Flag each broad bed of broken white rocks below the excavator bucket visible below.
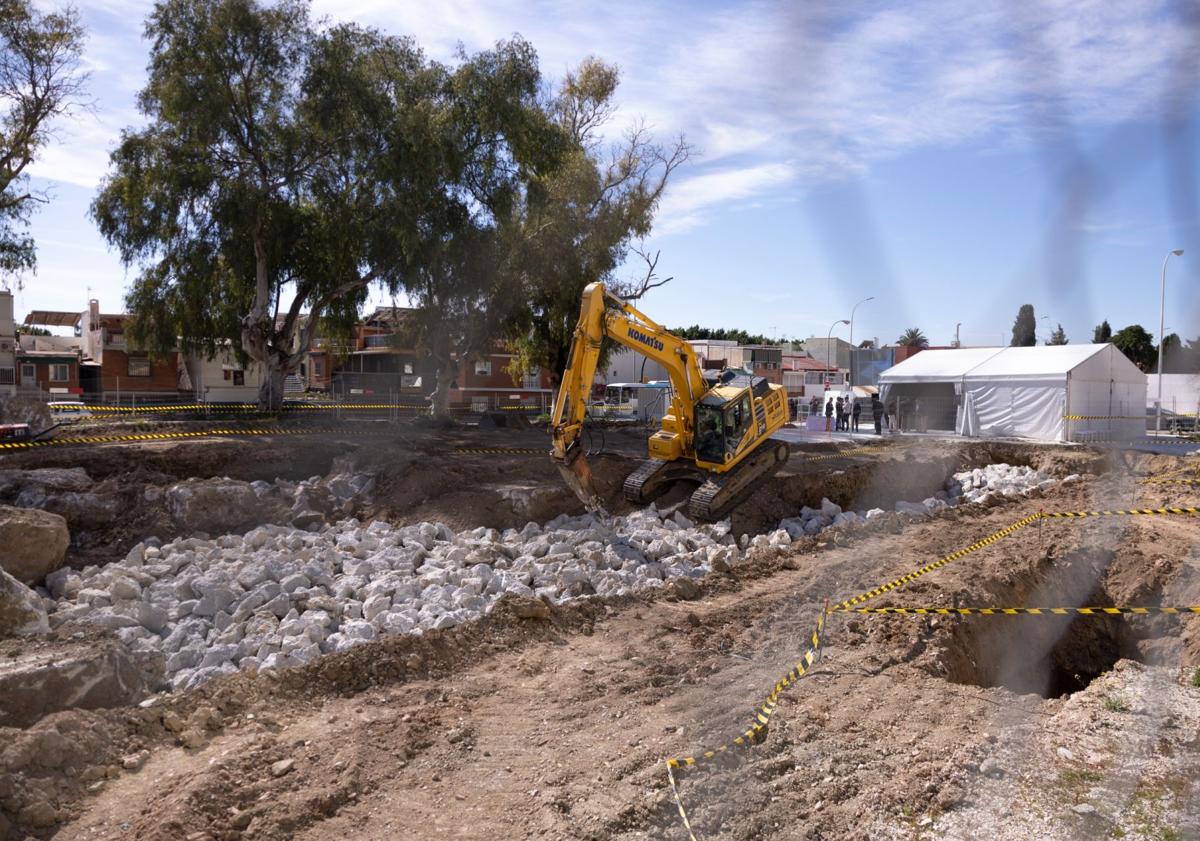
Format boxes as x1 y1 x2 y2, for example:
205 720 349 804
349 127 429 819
47 506 739 689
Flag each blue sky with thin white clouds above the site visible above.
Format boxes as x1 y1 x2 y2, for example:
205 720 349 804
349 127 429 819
17 0 1200 344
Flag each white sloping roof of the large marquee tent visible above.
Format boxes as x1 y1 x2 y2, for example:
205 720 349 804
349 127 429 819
880 344 1110 384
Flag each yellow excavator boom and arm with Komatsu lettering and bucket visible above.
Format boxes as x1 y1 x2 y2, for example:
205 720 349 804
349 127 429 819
551 283 708 511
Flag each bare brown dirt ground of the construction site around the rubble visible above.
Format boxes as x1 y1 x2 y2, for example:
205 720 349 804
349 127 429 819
0 425 1200 841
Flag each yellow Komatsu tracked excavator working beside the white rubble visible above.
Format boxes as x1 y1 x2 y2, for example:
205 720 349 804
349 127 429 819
551 283 788 522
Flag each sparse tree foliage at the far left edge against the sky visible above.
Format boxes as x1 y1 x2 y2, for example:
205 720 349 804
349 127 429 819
0 0 86 280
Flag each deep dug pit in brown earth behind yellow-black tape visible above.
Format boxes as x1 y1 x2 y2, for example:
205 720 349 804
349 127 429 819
937 548 1148 698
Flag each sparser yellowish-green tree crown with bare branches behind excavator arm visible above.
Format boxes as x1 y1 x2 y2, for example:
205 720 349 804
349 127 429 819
500 58 691 385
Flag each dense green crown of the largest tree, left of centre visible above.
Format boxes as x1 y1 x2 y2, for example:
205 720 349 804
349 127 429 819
92 0 547 406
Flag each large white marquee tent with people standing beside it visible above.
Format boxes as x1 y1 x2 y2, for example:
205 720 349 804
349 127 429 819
880 344 1146 440
